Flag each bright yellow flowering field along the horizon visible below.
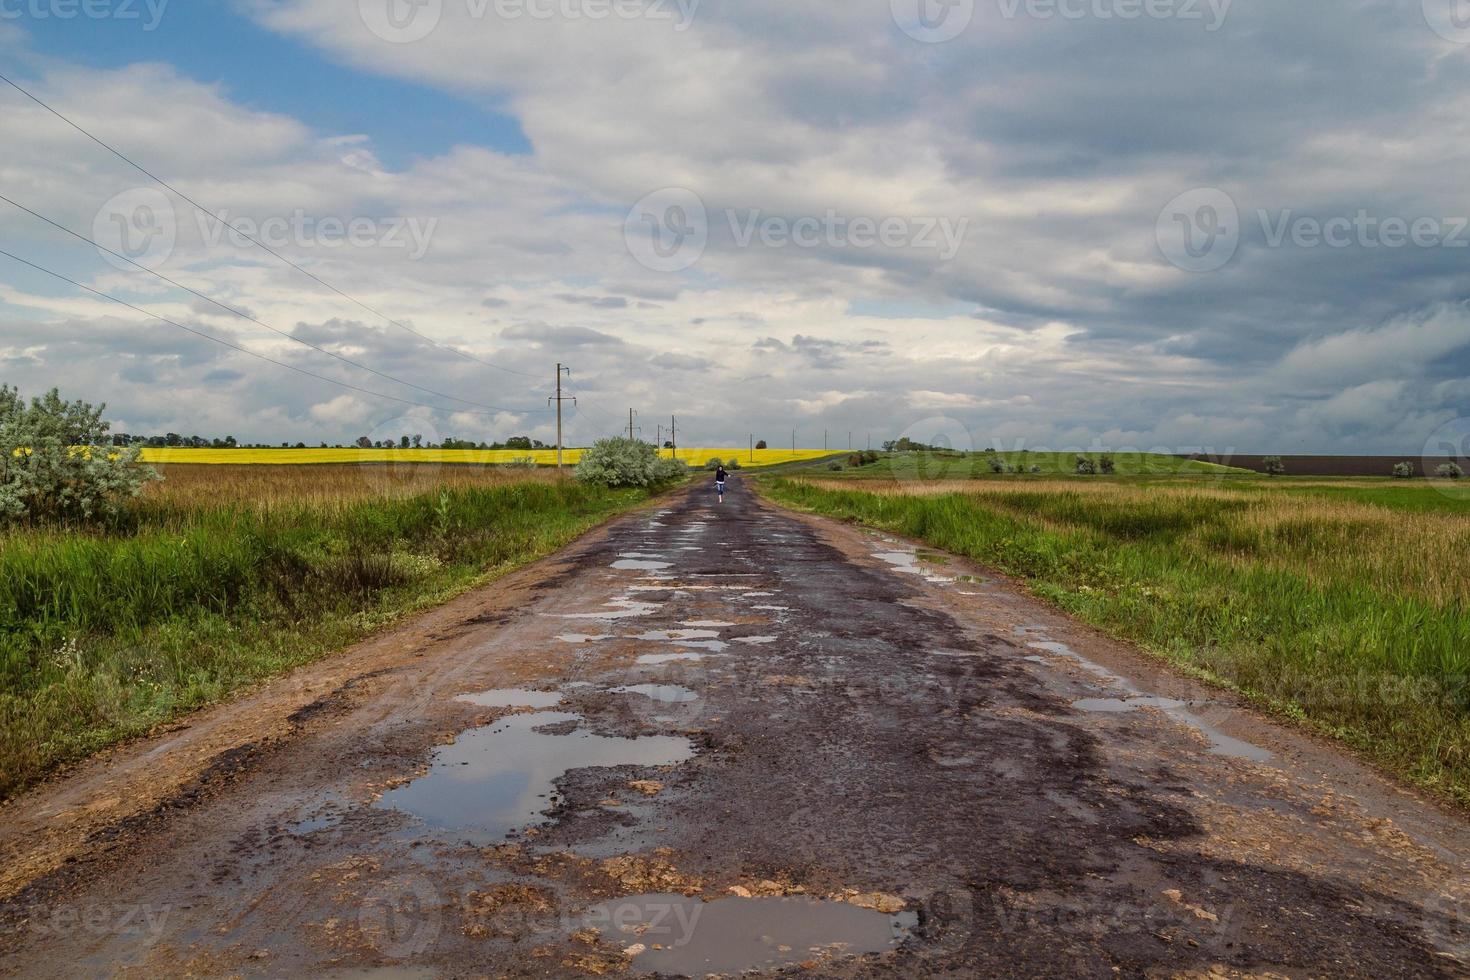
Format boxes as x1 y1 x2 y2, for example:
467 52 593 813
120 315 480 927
143 447 831 467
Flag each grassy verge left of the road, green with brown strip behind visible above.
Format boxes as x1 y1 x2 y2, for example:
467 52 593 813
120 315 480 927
0 466 647 796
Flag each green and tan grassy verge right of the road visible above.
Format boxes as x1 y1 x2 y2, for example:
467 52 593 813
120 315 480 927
766 467 1470 804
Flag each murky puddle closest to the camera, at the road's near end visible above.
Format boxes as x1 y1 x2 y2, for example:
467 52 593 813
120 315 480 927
587 895 917 977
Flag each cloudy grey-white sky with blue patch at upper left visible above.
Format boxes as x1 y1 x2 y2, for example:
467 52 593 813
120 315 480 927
0 0 1470 457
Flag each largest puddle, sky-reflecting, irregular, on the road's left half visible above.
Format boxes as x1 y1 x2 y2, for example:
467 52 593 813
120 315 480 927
373 711 694 843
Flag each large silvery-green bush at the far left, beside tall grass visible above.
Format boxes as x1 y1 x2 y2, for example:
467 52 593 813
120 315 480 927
0 385 159 523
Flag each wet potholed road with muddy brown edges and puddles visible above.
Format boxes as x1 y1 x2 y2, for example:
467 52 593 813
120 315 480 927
0 483 1470 977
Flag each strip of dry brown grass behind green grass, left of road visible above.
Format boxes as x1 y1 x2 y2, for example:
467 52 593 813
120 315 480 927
144 463 570 510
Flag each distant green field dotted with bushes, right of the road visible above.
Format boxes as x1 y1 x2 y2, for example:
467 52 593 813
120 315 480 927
832 453 1250 480
